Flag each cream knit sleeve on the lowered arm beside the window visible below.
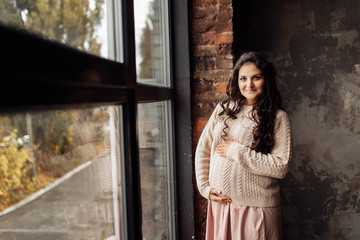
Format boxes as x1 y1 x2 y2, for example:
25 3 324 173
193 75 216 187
195 104 221 199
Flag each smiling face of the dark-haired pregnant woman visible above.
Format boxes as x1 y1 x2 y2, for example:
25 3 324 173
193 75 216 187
238 63 265 105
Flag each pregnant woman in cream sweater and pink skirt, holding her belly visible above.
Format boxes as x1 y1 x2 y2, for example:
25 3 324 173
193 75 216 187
195 52 291 240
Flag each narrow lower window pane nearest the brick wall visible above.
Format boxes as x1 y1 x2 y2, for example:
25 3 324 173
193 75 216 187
138 102 175 239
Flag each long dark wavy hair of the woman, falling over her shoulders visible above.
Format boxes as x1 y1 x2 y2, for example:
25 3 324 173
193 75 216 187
219 52 283 154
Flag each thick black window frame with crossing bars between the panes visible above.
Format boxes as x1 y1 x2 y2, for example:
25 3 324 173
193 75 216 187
0 0 195 239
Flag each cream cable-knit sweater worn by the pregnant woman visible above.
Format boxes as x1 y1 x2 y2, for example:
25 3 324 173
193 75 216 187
195 104 291 207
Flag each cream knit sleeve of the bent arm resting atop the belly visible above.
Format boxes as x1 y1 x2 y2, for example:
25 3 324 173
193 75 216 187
226 110 292 179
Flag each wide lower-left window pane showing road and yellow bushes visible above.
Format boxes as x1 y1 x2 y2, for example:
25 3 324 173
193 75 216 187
0 106 123 240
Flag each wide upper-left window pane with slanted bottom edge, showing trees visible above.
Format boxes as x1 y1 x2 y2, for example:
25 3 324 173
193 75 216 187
0 0 121 60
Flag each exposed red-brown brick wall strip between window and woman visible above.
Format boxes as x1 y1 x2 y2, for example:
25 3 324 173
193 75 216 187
190 0 234 239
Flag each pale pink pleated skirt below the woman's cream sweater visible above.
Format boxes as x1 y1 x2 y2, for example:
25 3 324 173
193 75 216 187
206 201 282 240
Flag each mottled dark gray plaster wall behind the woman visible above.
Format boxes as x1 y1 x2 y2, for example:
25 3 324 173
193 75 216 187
233 0 360 240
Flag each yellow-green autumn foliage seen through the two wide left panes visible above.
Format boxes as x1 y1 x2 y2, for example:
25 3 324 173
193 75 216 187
0 0 106 211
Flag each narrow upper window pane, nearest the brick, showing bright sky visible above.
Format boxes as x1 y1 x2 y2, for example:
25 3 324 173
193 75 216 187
134 0 171 87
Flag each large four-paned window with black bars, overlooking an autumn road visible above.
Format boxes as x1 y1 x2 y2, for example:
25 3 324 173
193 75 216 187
0 0 191 240
